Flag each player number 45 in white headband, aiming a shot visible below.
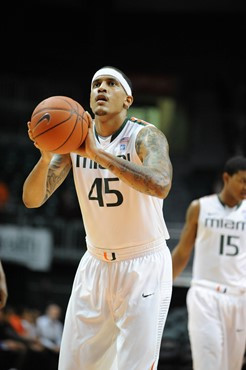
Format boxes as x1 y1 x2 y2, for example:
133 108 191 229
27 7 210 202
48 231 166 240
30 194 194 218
23 67 172 370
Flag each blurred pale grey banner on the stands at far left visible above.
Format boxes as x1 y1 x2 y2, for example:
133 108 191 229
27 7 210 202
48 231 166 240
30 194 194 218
0 225 53 271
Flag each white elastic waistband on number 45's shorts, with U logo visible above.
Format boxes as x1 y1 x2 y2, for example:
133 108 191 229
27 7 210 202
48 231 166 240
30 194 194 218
87 238 167 262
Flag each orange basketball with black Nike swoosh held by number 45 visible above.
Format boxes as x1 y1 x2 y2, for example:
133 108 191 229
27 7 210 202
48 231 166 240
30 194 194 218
30 96 88 154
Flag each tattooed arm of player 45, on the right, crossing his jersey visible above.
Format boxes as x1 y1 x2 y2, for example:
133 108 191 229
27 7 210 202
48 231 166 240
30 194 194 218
77 115 172 198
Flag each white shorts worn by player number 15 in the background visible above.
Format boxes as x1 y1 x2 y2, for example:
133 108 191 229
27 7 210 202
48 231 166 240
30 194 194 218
187 281 246 370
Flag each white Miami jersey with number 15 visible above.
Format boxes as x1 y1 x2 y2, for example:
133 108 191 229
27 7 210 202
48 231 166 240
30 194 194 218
193 194 246 288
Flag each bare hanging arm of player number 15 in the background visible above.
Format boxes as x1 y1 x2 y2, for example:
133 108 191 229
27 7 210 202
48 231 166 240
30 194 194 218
172 200 200 279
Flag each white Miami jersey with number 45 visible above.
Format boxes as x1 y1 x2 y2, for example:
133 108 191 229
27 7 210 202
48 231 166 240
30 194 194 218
71 118 169 250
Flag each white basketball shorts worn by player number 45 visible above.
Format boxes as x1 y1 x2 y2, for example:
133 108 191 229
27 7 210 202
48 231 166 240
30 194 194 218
58 239 172 370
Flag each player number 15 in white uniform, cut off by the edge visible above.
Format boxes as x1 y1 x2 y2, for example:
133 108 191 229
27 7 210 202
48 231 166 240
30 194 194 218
172 156 246 370
